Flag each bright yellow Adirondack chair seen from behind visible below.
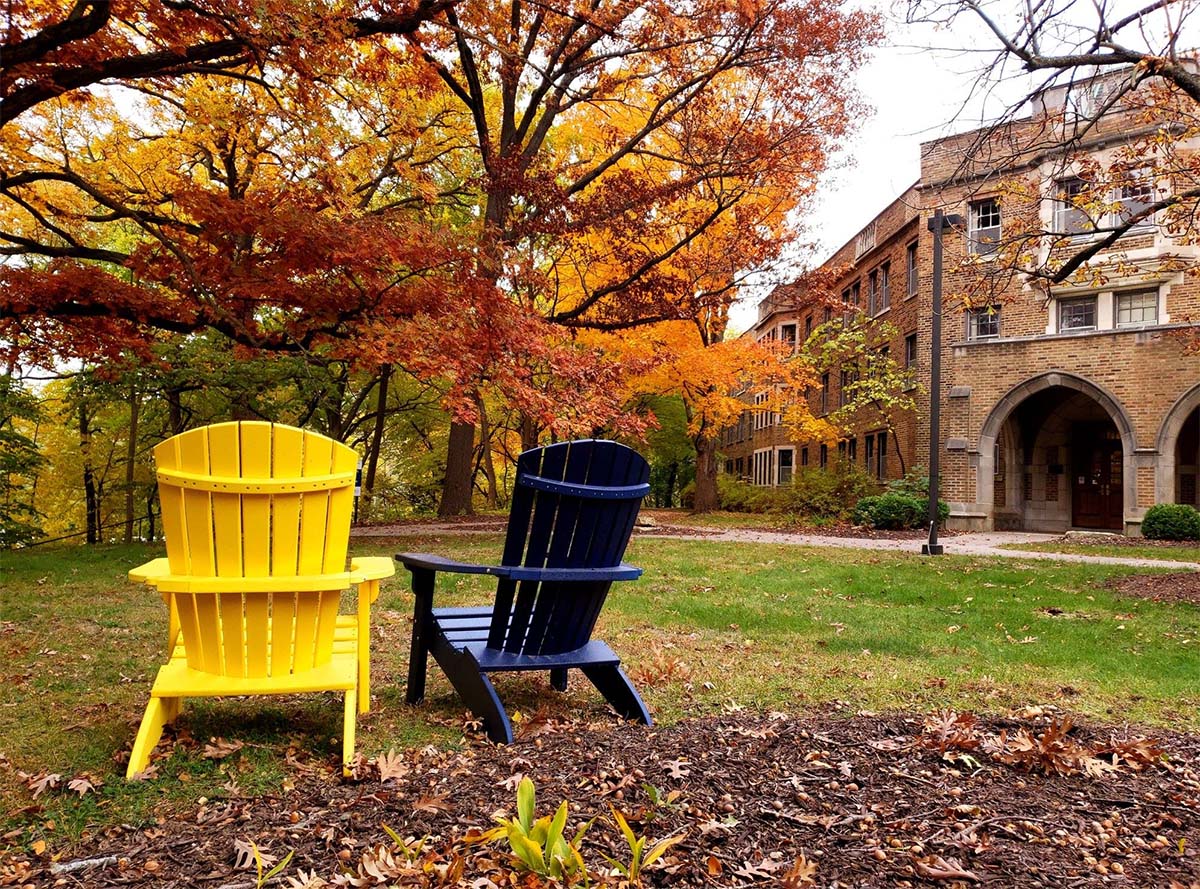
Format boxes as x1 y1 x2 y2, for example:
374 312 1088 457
126 422 395 779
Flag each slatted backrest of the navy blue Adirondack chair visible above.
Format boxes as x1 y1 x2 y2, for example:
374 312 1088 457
488 439 650 655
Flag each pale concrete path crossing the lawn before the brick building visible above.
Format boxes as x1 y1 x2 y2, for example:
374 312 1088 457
350 518 1200 571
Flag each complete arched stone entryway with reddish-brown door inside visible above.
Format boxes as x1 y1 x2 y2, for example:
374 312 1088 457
976 371 1138 531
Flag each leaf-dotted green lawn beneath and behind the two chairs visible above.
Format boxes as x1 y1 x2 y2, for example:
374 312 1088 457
0 535 1200 839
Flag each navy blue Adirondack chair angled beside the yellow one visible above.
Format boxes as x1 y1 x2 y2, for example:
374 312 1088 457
396 440 652 744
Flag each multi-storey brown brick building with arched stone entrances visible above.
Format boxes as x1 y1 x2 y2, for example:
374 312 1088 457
722 73 1200 534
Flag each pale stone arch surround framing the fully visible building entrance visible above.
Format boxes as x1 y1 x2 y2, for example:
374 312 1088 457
974 371 1132 522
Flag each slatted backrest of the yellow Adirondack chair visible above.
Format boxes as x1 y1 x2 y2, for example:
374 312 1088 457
155 421 358 678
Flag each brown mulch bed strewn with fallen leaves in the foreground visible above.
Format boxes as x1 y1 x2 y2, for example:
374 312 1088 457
9 708 1200 889
